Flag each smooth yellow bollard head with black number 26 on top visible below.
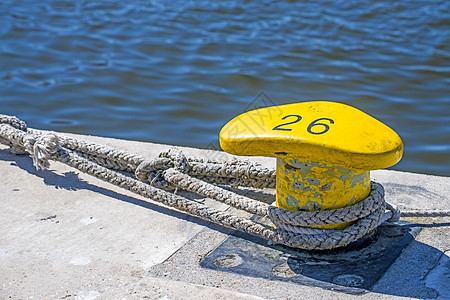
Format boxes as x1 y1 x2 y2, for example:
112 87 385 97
219 101 403 170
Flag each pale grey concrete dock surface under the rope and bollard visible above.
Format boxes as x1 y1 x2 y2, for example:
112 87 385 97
0 134 450 300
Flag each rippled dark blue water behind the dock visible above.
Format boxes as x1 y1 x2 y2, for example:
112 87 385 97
0 0 450 176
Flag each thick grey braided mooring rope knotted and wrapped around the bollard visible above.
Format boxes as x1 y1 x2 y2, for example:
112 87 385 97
0 115 450 250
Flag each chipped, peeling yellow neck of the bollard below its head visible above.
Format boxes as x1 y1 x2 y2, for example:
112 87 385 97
276 157 370 229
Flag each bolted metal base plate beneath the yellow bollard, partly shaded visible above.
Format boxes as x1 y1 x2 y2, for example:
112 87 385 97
200 222 420 294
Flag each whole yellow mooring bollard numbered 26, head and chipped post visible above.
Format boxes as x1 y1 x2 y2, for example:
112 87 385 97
220 101 403 229
